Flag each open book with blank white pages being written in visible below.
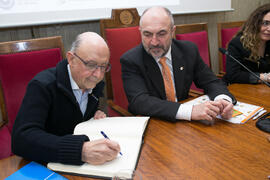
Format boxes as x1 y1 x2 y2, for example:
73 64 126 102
47 117 149 178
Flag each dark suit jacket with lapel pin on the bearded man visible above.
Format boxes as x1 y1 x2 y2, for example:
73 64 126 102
120 40 234 121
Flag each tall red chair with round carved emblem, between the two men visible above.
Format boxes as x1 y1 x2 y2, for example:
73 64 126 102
100 8 141 116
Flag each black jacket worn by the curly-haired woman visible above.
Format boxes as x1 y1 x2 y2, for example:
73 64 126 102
223 35 270 83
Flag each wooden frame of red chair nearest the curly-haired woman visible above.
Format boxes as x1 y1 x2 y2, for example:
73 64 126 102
217 21 245 77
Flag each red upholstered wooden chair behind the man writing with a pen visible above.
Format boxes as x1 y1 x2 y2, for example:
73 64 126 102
0 36 64 159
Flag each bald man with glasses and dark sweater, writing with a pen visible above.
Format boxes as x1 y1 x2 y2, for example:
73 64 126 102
12 32 120 164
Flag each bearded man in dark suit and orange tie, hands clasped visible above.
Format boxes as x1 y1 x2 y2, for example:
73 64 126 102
120 7 235 123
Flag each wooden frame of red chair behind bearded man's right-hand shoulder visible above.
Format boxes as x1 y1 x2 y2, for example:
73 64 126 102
175 22 212 97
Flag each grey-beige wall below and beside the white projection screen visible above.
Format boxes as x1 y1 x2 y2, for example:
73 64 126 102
0 0 270 119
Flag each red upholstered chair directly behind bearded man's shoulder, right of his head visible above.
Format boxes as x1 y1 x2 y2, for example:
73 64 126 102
175 23 211 96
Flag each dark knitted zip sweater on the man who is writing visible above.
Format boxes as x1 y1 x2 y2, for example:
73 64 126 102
12 60 104 164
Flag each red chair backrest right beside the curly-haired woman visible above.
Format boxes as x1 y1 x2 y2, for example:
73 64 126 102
217 21 245 74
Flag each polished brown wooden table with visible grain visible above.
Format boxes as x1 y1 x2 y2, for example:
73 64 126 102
0 84 270 180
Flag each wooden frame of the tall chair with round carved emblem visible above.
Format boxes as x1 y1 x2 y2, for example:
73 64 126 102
100 8 140 116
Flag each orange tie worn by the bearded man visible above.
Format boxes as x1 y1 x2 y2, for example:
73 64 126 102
159 57 175 102
